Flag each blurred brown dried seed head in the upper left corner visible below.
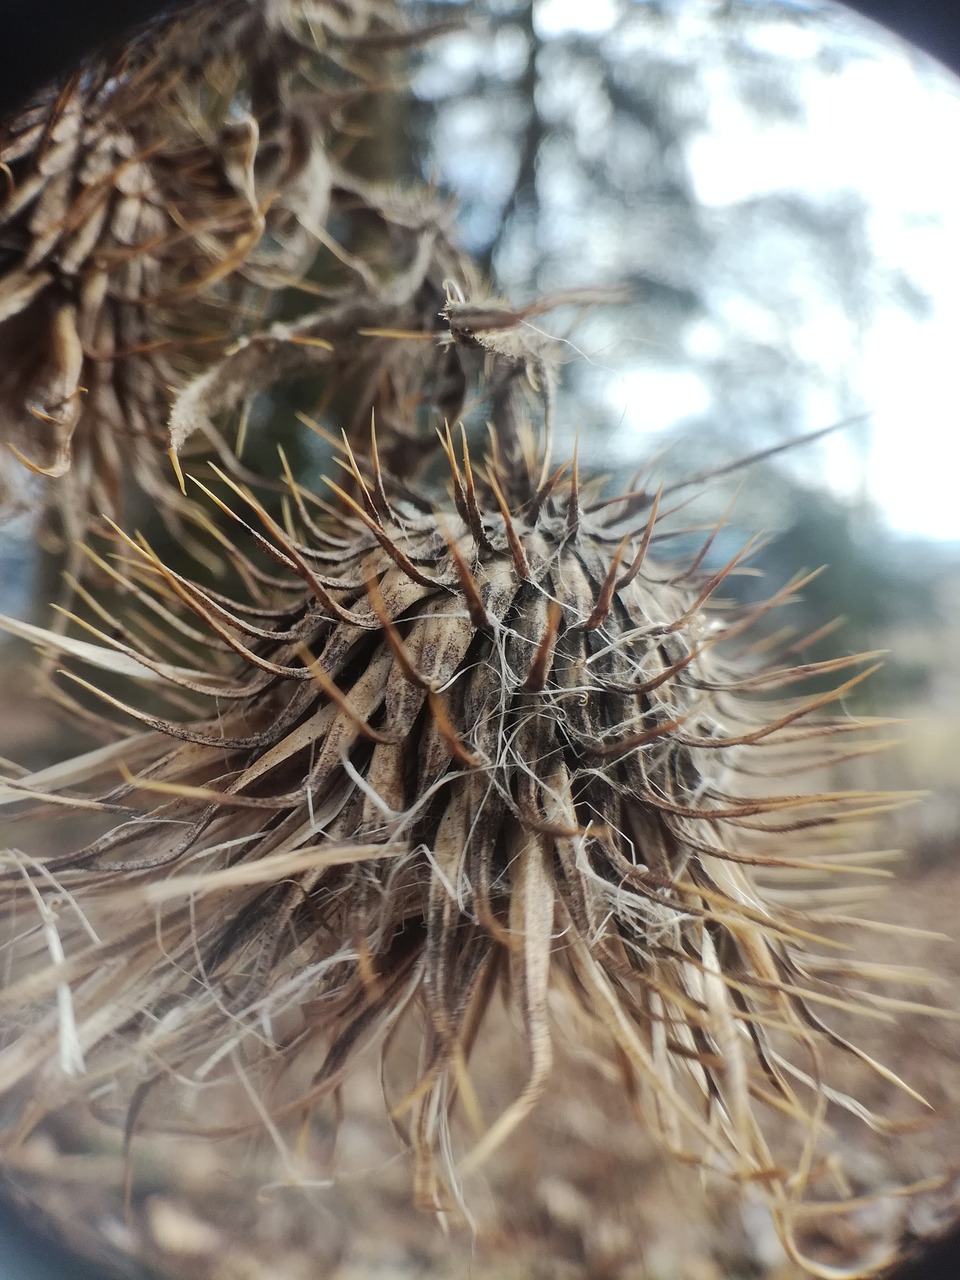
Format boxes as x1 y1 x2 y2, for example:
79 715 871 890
0 0 432 536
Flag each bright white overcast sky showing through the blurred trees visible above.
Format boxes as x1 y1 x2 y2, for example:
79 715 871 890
552 0 960 540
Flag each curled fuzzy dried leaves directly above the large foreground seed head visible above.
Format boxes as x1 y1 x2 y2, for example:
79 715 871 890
169 168 481 479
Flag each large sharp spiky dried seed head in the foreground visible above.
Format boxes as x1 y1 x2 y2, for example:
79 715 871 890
0 401 942 1269
